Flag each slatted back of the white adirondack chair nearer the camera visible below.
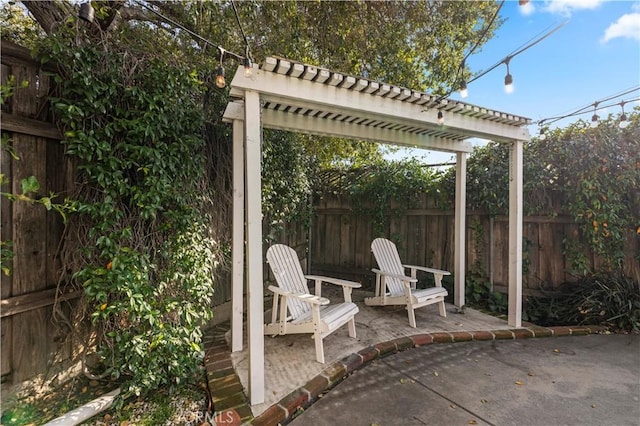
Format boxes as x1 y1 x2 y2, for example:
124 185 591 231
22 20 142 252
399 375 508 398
267 244 311 319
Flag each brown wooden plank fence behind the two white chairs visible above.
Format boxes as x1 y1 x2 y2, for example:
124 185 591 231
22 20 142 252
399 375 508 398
310 196 640 294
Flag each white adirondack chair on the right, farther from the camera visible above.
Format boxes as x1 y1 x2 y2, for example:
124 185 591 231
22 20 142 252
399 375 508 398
364 238 451 328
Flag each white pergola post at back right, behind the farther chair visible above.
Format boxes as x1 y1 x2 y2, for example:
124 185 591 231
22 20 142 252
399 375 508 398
453 152 467 307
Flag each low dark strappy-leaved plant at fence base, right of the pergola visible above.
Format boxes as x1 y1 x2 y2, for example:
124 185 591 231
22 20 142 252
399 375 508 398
524 273 640 332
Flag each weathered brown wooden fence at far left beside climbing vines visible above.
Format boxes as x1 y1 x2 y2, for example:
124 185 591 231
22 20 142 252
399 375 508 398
0 40 79 391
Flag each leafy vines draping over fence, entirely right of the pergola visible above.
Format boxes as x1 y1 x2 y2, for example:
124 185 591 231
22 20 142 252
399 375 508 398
525 113 640 274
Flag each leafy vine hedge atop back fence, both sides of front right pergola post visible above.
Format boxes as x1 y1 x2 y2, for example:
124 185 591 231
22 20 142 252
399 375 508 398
440 112 640 275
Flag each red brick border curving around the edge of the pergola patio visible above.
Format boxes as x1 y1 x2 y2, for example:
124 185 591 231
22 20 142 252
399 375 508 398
205 324 607 426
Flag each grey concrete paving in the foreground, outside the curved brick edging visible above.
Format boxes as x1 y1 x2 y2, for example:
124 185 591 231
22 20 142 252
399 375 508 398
291 335 640 426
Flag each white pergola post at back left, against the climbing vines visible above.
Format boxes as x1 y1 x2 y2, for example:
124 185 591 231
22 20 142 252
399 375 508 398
231 120 245 352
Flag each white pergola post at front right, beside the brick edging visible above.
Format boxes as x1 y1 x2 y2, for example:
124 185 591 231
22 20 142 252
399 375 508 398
508 140 523 327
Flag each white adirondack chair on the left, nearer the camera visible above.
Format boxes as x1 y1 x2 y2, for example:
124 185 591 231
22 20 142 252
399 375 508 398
264 244 361 364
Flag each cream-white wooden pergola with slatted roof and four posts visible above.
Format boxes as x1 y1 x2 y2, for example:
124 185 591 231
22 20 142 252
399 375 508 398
224 57 531 405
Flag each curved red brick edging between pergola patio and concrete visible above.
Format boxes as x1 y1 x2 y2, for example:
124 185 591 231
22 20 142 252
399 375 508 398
206 325 606 426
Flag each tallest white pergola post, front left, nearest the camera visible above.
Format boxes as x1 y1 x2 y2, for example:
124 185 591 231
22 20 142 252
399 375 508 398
244 91 264 405
